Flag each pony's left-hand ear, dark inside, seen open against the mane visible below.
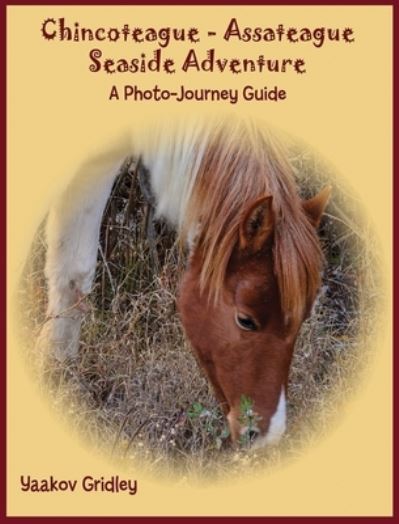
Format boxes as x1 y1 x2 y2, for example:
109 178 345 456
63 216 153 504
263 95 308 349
239 195 274 253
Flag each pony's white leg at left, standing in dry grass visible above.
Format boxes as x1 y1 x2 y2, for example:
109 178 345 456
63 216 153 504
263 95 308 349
37 149 126 360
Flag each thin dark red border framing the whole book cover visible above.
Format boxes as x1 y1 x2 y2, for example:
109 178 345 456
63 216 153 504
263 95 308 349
0 0 399 523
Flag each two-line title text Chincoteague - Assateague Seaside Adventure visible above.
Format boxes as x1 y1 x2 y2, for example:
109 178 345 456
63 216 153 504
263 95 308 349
40 17 355 101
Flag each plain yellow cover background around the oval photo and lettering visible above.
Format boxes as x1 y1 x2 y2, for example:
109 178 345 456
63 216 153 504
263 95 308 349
7 6 392 515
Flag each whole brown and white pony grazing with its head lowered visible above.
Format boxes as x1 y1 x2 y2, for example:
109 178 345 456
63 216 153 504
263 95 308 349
39 120 330 446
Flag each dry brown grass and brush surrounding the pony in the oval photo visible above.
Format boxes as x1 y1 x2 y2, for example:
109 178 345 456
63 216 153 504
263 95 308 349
20 144 380 484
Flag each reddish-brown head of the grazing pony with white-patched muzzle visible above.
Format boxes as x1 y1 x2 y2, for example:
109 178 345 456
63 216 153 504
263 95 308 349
179 188 330 445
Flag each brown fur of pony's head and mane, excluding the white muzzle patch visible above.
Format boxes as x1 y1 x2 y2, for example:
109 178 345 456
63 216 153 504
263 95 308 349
179 122 329 440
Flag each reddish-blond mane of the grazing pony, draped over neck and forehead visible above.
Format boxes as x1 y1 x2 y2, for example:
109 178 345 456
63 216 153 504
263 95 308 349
145 120 322 321
